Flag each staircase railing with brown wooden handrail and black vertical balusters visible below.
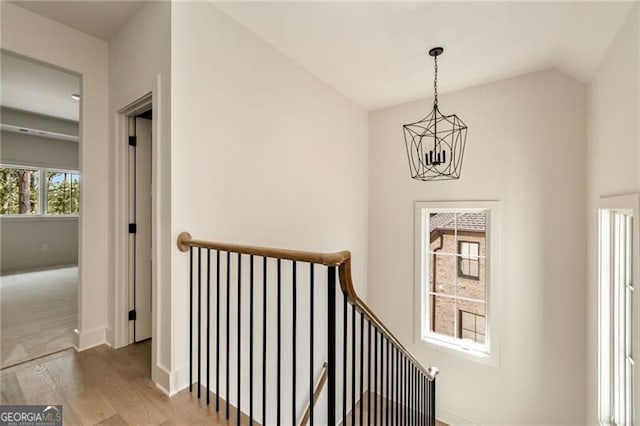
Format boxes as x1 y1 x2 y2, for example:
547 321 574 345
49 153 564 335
178 232 438 426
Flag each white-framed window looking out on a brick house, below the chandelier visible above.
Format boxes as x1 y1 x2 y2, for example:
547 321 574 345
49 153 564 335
416 201 498 365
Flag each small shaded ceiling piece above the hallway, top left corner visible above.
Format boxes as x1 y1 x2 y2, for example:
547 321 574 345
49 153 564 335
11 0 148 41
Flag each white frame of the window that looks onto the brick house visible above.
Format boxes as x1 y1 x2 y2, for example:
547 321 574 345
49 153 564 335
414 201 500 367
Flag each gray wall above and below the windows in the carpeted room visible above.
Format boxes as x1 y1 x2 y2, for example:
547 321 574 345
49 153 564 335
0 108 79 274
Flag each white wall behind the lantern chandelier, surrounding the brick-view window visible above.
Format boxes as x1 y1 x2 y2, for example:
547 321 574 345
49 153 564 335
368 71 586 425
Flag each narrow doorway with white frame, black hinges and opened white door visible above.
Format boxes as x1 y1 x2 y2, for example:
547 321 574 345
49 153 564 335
113 93 158 382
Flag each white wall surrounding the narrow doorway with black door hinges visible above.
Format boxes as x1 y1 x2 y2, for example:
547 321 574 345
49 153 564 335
107 2 175 390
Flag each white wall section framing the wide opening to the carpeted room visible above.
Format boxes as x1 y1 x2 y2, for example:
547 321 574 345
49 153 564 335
0 1 110 349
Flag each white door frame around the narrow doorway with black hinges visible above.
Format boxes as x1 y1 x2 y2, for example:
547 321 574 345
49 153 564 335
113 92 160 376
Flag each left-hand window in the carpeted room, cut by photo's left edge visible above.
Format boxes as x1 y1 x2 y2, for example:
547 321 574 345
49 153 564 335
0 166 40 215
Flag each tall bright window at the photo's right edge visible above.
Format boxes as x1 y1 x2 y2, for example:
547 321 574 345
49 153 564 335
598 196 640 425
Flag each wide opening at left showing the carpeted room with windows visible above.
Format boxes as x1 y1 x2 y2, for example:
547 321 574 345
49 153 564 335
0 51 82 368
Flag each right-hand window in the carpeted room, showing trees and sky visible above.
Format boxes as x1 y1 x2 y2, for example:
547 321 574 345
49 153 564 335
47 170 80 215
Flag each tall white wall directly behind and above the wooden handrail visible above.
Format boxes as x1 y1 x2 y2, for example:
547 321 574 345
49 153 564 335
171 2 368 413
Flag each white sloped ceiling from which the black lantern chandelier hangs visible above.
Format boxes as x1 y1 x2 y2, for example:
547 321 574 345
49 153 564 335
216 1 634 110
